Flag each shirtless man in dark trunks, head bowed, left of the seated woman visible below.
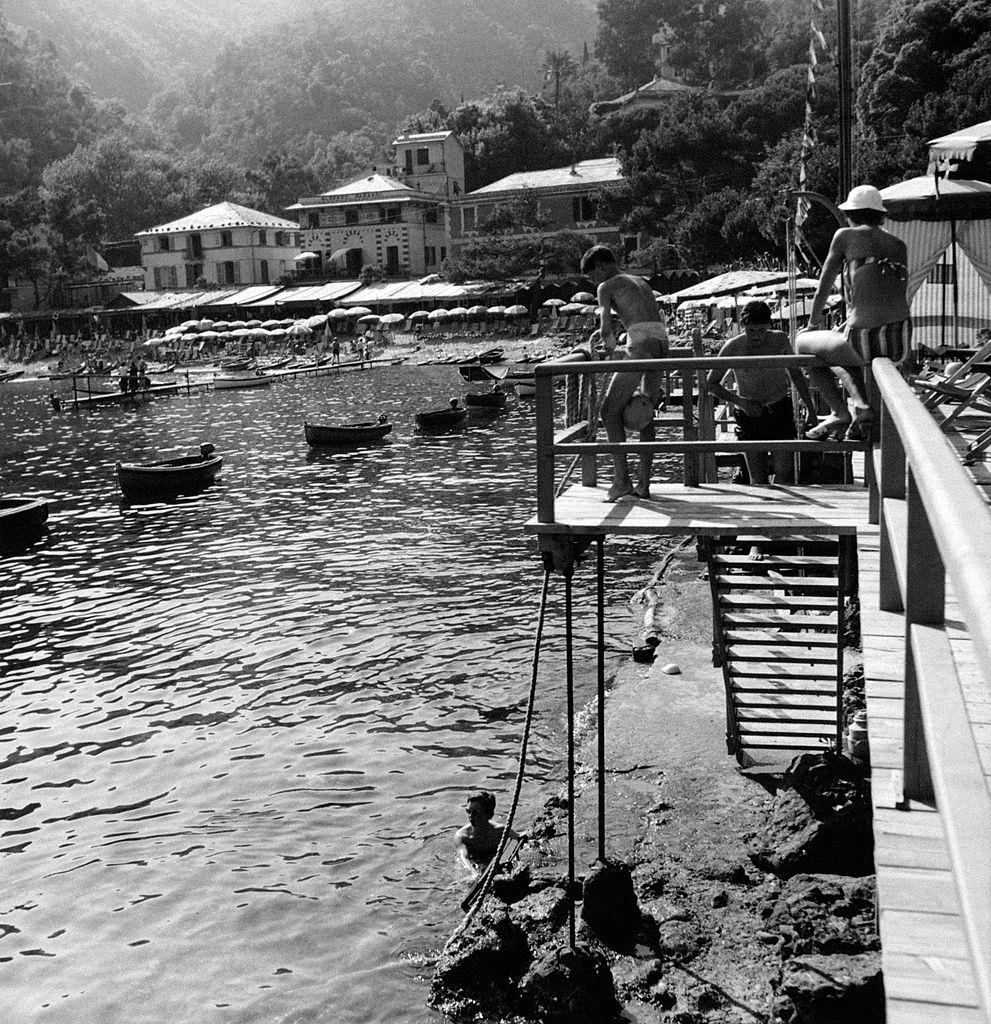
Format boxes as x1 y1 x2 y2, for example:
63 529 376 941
707 301 818 483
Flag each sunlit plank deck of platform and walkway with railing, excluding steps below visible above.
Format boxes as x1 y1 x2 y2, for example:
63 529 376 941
524 358 991 1024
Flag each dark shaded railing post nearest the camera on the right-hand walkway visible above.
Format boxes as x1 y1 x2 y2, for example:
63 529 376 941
902 468 946 801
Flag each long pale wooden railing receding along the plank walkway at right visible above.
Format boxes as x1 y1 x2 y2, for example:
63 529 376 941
871 359 991 1015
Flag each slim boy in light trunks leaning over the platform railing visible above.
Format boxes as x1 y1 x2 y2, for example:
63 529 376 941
581 246 667 502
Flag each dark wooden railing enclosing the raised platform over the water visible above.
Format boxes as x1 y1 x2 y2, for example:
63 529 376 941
534 349 861 523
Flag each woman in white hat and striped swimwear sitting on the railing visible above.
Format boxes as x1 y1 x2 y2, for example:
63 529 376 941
795 185 912 440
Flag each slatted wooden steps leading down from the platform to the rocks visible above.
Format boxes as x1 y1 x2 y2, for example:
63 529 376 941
707 536 855 764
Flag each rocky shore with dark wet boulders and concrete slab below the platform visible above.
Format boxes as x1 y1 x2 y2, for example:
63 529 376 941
431 549 884 1024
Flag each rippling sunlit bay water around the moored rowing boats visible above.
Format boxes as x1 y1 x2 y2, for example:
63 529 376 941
0 367 671 1024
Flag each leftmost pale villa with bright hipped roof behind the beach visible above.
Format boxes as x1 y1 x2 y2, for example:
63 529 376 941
135 203 300 291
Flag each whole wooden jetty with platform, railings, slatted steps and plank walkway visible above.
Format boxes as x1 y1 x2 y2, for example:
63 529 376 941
525 355 991 1024
